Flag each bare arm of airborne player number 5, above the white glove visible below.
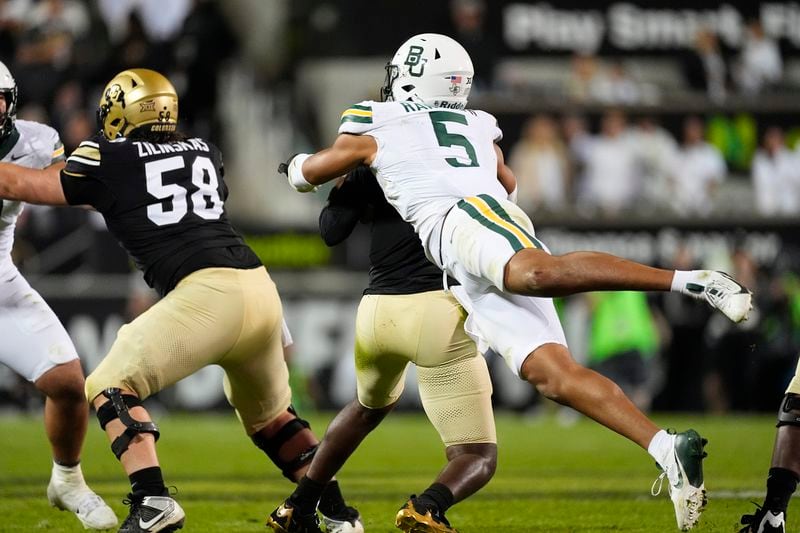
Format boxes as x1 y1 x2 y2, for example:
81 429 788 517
302 133 378 185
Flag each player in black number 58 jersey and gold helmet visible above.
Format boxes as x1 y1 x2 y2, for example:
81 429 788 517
0 69 363 533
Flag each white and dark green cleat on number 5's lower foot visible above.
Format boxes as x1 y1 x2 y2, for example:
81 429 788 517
651 429 707 531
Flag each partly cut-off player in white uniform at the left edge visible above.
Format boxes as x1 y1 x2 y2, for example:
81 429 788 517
0 63 117 529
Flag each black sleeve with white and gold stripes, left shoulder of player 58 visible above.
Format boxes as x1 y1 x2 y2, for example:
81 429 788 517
61 140 114 213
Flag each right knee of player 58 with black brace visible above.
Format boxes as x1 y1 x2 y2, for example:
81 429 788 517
250 406 319 481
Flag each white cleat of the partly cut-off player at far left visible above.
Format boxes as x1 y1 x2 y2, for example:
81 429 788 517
47 476 118 530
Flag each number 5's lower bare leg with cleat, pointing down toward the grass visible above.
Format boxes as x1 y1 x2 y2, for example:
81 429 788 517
520 344 706 531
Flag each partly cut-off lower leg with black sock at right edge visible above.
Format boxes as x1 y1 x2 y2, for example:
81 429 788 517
740 390 800 533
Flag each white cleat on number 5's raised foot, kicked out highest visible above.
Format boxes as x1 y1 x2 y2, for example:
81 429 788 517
684 270 753 323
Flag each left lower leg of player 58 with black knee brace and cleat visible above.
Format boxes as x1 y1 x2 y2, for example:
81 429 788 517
90 386 186 533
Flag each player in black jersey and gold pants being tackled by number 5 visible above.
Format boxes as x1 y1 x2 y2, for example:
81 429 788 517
268 166 497 533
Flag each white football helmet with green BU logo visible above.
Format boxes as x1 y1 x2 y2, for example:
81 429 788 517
381 33 475 109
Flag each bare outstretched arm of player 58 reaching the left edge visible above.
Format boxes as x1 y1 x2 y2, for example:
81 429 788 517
0 161 67 205
